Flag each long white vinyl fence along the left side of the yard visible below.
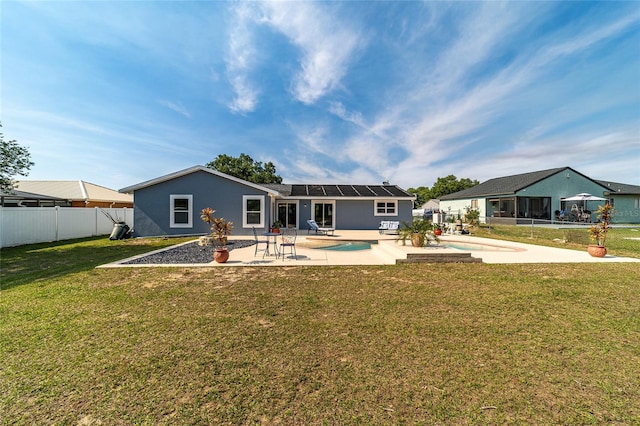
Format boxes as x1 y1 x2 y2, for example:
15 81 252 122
0 207 133 247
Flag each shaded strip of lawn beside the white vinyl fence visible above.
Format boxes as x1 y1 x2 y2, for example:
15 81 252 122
0 236 184 290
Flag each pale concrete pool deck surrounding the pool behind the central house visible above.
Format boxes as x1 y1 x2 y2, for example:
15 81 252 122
99 231 640 268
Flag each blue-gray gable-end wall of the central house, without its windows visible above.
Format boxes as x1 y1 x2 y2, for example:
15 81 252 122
134 171 271 236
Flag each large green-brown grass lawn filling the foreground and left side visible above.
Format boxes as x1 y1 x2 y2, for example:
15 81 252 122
0 239 640 425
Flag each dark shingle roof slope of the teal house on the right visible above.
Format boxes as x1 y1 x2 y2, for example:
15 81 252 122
440 167 577 200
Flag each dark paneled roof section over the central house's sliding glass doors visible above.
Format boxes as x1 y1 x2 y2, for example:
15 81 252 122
263 184 414 198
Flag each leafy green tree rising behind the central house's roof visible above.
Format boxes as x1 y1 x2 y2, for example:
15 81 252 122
206 153 282 183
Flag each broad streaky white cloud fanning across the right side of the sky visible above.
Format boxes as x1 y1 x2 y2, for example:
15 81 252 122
345 8 638 186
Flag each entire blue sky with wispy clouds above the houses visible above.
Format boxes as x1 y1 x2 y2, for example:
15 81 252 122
0 1 640 189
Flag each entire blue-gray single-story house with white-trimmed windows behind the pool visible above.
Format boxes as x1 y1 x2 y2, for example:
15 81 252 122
120 166 415 236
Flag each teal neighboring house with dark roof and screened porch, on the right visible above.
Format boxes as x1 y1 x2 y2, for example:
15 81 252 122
440 167 640 223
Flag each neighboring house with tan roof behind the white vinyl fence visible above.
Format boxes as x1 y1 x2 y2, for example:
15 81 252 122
15 180 133 208
